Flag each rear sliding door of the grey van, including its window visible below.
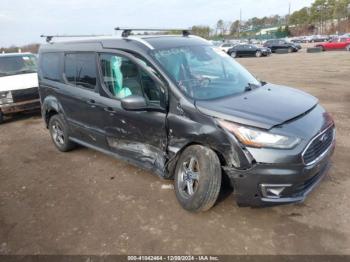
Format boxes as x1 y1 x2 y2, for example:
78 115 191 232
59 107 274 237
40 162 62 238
60 52 105 147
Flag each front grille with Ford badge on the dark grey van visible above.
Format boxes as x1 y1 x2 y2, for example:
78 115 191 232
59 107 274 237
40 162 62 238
303 126 334 165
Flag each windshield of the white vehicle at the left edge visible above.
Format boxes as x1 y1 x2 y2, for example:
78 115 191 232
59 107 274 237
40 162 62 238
0 55 37 76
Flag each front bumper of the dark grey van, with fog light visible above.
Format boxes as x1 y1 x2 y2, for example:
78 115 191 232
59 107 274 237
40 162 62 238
223 141 335 207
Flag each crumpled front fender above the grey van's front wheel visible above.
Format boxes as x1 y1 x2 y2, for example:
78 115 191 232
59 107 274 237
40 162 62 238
167 96 253 174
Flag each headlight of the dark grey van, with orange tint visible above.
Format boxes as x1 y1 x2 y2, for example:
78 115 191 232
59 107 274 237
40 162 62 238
218 120 300 149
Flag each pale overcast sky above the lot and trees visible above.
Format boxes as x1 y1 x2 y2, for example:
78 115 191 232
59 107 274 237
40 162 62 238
0 0 313 47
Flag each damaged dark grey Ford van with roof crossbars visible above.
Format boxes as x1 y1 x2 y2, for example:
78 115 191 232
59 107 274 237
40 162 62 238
39 31 335 211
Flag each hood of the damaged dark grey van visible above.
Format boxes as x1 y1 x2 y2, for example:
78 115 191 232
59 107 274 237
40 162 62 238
195 84 318 129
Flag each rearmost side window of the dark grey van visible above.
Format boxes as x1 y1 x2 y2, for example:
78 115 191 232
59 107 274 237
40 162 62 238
40 53 62 82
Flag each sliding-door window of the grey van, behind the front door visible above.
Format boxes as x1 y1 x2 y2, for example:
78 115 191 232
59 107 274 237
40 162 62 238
64 53 97 89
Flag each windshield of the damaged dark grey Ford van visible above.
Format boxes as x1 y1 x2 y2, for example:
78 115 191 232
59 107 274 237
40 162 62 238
153 46 261 100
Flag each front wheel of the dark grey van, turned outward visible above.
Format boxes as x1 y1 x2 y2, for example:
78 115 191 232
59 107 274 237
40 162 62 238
175 145 222 212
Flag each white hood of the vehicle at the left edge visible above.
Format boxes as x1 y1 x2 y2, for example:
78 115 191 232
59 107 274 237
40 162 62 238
0 73 38 92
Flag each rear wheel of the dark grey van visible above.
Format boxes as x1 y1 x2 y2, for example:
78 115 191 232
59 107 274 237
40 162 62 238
49 115 75 152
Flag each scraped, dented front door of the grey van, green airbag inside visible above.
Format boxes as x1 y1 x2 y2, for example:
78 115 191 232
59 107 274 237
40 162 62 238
97 52 167 170
